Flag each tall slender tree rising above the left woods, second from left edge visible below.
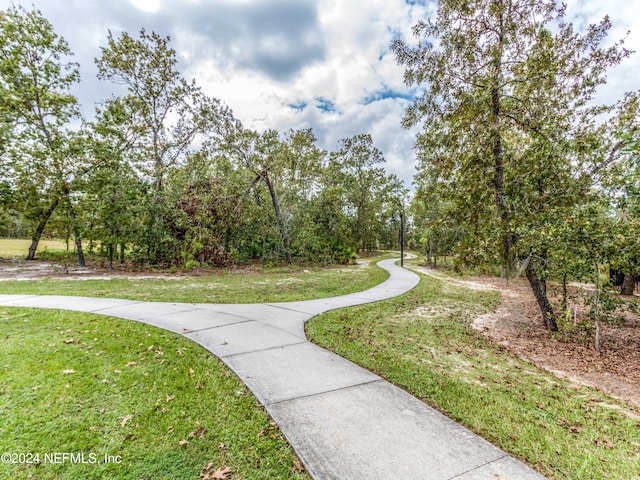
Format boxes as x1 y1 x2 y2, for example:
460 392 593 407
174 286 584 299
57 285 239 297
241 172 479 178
96 30 231 261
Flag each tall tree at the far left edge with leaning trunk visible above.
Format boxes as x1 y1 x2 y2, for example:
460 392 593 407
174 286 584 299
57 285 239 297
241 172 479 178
0 6 84 264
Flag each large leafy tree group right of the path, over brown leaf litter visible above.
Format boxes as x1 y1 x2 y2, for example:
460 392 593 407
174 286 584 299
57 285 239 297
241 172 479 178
392 0 640 347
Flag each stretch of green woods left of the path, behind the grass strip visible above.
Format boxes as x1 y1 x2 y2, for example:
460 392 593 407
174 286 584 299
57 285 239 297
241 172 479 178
0 7 406 268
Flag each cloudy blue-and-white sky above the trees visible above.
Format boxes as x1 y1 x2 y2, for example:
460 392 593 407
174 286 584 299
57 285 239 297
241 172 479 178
0 0 640 188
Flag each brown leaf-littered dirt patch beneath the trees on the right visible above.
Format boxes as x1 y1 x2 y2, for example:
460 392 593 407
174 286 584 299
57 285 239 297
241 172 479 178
417 267 640 407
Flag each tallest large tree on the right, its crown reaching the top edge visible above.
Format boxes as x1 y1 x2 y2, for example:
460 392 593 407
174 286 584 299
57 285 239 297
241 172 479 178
392 0 630 330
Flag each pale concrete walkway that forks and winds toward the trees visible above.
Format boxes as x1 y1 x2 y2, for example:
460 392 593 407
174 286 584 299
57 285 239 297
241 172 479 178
0 260 544 480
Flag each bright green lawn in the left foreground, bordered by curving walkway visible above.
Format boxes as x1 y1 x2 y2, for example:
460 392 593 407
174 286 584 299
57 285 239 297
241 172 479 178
0 307 309 480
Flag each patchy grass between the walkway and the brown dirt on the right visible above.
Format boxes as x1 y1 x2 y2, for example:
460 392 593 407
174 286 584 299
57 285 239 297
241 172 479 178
307 266 640 480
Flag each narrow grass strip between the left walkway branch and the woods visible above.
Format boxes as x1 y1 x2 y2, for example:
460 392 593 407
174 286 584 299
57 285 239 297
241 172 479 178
0 258 389 303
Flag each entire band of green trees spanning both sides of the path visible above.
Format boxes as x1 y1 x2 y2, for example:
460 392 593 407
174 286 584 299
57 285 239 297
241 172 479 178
5 0 640 342
